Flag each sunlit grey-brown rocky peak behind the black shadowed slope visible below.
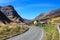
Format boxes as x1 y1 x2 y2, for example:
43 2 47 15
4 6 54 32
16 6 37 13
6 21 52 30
0 5 23 22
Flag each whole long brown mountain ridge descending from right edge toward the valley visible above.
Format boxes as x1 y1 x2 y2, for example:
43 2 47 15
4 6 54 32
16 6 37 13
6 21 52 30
34 9 60 20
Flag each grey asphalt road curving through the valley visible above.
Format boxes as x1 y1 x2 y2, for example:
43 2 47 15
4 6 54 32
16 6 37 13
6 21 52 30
7 26 44 40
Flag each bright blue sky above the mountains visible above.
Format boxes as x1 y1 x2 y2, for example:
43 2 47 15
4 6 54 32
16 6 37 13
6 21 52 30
0 0 60 19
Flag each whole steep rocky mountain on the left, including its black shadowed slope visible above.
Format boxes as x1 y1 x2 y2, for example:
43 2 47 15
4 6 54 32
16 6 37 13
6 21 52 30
0 5 23 23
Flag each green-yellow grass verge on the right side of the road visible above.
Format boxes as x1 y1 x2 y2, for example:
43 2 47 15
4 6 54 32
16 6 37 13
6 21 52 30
37 24 59 40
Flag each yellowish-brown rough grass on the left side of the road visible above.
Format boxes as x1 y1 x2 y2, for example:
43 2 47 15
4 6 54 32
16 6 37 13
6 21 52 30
0 24 28 40
